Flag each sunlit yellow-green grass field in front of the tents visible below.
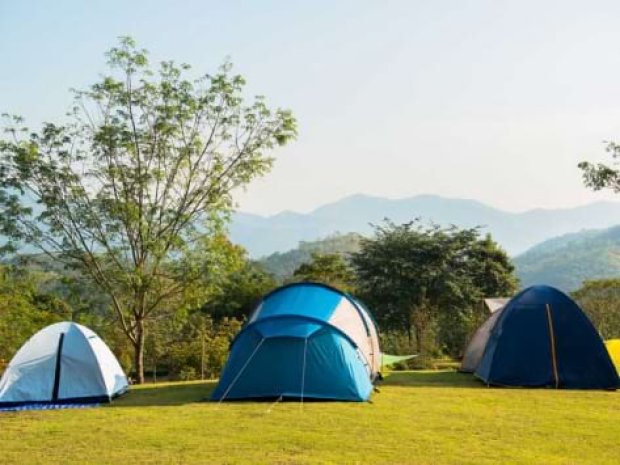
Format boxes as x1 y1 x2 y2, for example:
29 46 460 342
0 372 620 465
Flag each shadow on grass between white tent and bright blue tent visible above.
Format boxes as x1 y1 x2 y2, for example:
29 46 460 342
111 381 216 407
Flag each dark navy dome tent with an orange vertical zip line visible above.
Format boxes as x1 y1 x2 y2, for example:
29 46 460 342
475 286 619 389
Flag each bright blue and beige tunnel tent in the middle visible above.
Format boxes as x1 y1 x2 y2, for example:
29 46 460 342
212 283 381 401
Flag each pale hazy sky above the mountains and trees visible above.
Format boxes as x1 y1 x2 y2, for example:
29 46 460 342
0 0 620 213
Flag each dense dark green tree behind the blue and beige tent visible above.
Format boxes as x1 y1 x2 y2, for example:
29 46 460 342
353 221 516 353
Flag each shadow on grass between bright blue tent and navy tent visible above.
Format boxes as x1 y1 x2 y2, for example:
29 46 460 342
378 371 484 389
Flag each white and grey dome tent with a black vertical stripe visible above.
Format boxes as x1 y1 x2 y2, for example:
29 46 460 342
0 322 128 407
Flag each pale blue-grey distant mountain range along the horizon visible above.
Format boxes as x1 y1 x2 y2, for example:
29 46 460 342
230 195 620 258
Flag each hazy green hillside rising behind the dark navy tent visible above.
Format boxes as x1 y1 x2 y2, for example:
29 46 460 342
514 226 620 291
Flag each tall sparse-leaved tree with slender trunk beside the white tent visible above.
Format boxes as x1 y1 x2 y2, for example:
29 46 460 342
0 38 296 382
